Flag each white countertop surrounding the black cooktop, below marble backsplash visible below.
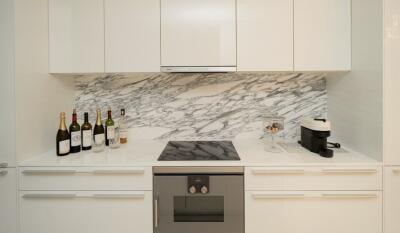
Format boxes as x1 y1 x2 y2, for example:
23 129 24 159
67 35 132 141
19 140 382 167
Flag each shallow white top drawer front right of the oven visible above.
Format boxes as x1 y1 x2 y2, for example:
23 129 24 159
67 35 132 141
245 167 382 190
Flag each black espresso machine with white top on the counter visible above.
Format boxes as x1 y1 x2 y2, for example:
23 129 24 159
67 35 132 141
299 118 340 158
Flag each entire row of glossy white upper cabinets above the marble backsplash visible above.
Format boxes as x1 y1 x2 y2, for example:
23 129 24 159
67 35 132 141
49 0 351 73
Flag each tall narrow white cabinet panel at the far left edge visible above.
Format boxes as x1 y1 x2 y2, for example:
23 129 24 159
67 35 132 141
0 0 15 166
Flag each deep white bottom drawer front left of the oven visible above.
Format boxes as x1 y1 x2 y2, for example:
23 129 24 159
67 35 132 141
20 191 153 233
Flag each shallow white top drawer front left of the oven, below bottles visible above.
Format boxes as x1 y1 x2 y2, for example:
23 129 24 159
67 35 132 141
20 167 152 190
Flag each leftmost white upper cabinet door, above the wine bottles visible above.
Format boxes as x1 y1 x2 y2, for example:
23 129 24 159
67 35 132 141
49 0 104 73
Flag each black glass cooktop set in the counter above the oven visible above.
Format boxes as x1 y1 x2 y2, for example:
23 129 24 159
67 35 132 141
158 141 240 161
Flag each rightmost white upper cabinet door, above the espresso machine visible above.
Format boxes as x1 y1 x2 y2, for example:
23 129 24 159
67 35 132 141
294 0 351 71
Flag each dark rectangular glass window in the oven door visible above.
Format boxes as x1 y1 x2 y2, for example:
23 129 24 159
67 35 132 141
174 196 224 222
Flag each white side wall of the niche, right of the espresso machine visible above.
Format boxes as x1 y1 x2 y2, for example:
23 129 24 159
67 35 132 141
327 0 383 160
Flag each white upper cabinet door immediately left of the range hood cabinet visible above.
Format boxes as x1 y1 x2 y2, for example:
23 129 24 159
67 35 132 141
105 0 160 73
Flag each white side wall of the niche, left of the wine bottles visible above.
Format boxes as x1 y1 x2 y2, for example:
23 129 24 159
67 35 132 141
15 0 74 161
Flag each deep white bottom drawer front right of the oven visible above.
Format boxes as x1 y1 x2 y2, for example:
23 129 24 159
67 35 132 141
245 191 382 233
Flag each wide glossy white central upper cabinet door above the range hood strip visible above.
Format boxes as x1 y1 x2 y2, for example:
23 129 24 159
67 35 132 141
161 0 236 66
